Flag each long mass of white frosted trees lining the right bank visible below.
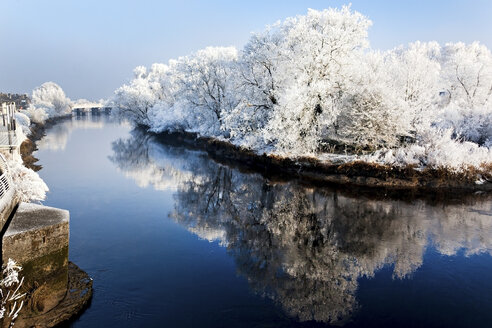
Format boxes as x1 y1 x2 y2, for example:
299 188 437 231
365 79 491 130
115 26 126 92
112 7 492 169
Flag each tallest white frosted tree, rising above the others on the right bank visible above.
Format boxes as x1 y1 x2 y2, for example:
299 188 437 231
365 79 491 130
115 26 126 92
265 7 371 153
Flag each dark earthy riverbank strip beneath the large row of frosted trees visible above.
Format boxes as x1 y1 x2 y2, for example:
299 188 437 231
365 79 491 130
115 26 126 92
151 127 492 192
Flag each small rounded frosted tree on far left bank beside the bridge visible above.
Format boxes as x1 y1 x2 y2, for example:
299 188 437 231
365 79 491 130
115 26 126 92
26 82 72 123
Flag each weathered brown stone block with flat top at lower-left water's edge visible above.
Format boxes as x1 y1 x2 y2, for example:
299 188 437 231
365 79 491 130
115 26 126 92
2 203 69 321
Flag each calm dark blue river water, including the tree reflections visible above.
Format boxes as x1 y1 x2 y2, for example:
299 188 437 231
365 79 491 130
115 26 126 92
34 116 492 327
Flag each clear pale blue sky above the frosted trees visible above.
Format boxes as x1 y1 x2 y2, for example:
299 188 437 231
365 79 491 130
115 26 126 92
0 0 492 100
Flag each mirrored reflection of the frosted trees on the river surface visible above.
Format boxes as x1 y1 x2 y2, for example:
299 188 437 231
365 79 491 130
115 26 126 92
111 130 492 323
